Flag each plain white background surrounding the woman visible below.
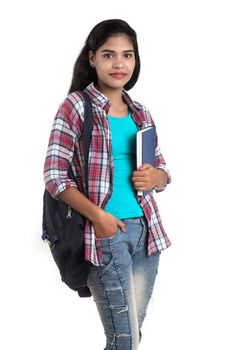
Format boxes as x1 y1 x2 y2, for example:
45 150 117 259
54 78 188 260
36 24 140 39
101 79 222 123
0 0 234 350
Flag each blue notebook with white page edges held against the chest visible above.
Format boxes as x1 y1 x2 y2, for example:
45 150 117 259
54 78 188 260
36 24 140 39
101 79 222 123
136 126 156 196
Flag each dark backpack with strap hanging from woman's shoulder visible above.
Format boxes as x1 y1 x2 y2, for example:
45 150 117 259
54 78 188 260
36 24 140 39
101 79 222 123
41 91 93 297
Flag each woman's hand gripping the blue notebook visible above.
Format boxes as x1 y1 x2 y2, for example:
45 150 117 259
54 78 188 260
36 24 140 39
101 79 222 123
132 164 168 192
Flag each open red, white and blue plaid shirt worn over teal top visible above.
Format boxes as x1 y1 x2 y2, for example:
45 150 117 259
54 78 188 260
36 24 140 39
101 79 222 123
44 83 171 265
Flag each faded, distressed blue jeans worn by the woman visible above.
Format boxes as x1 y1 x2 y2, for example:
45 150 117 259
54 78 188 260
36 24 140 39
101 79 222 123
88 217 160 350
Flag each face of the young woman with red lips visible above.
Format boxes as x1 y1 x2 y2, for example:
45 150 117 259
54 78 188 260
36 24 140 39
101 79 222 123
89 34 136 90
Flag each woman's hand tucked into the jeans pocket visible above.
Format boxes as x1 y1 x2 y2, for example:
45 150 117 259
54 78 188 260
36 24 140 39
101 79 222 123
92 210 126 238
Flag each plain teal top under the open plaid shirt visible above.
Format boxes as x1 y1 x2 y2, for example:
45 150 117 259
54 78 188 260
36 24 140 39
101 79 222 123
105 112 144 219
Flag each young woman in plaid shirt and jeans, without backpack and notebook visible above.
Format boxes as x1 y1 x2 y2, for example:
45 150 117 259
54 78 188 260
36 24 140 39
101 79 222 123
44 20 170 350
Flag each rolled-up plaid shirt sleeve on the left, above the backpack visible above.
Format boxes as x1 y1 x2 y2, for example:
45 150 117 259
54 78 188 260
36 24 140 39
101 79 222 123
44 100 78 199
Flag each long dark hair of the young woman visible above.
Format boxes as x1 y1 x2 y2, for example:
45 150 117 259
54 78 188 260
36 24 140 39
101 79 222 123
68 19 140 93
